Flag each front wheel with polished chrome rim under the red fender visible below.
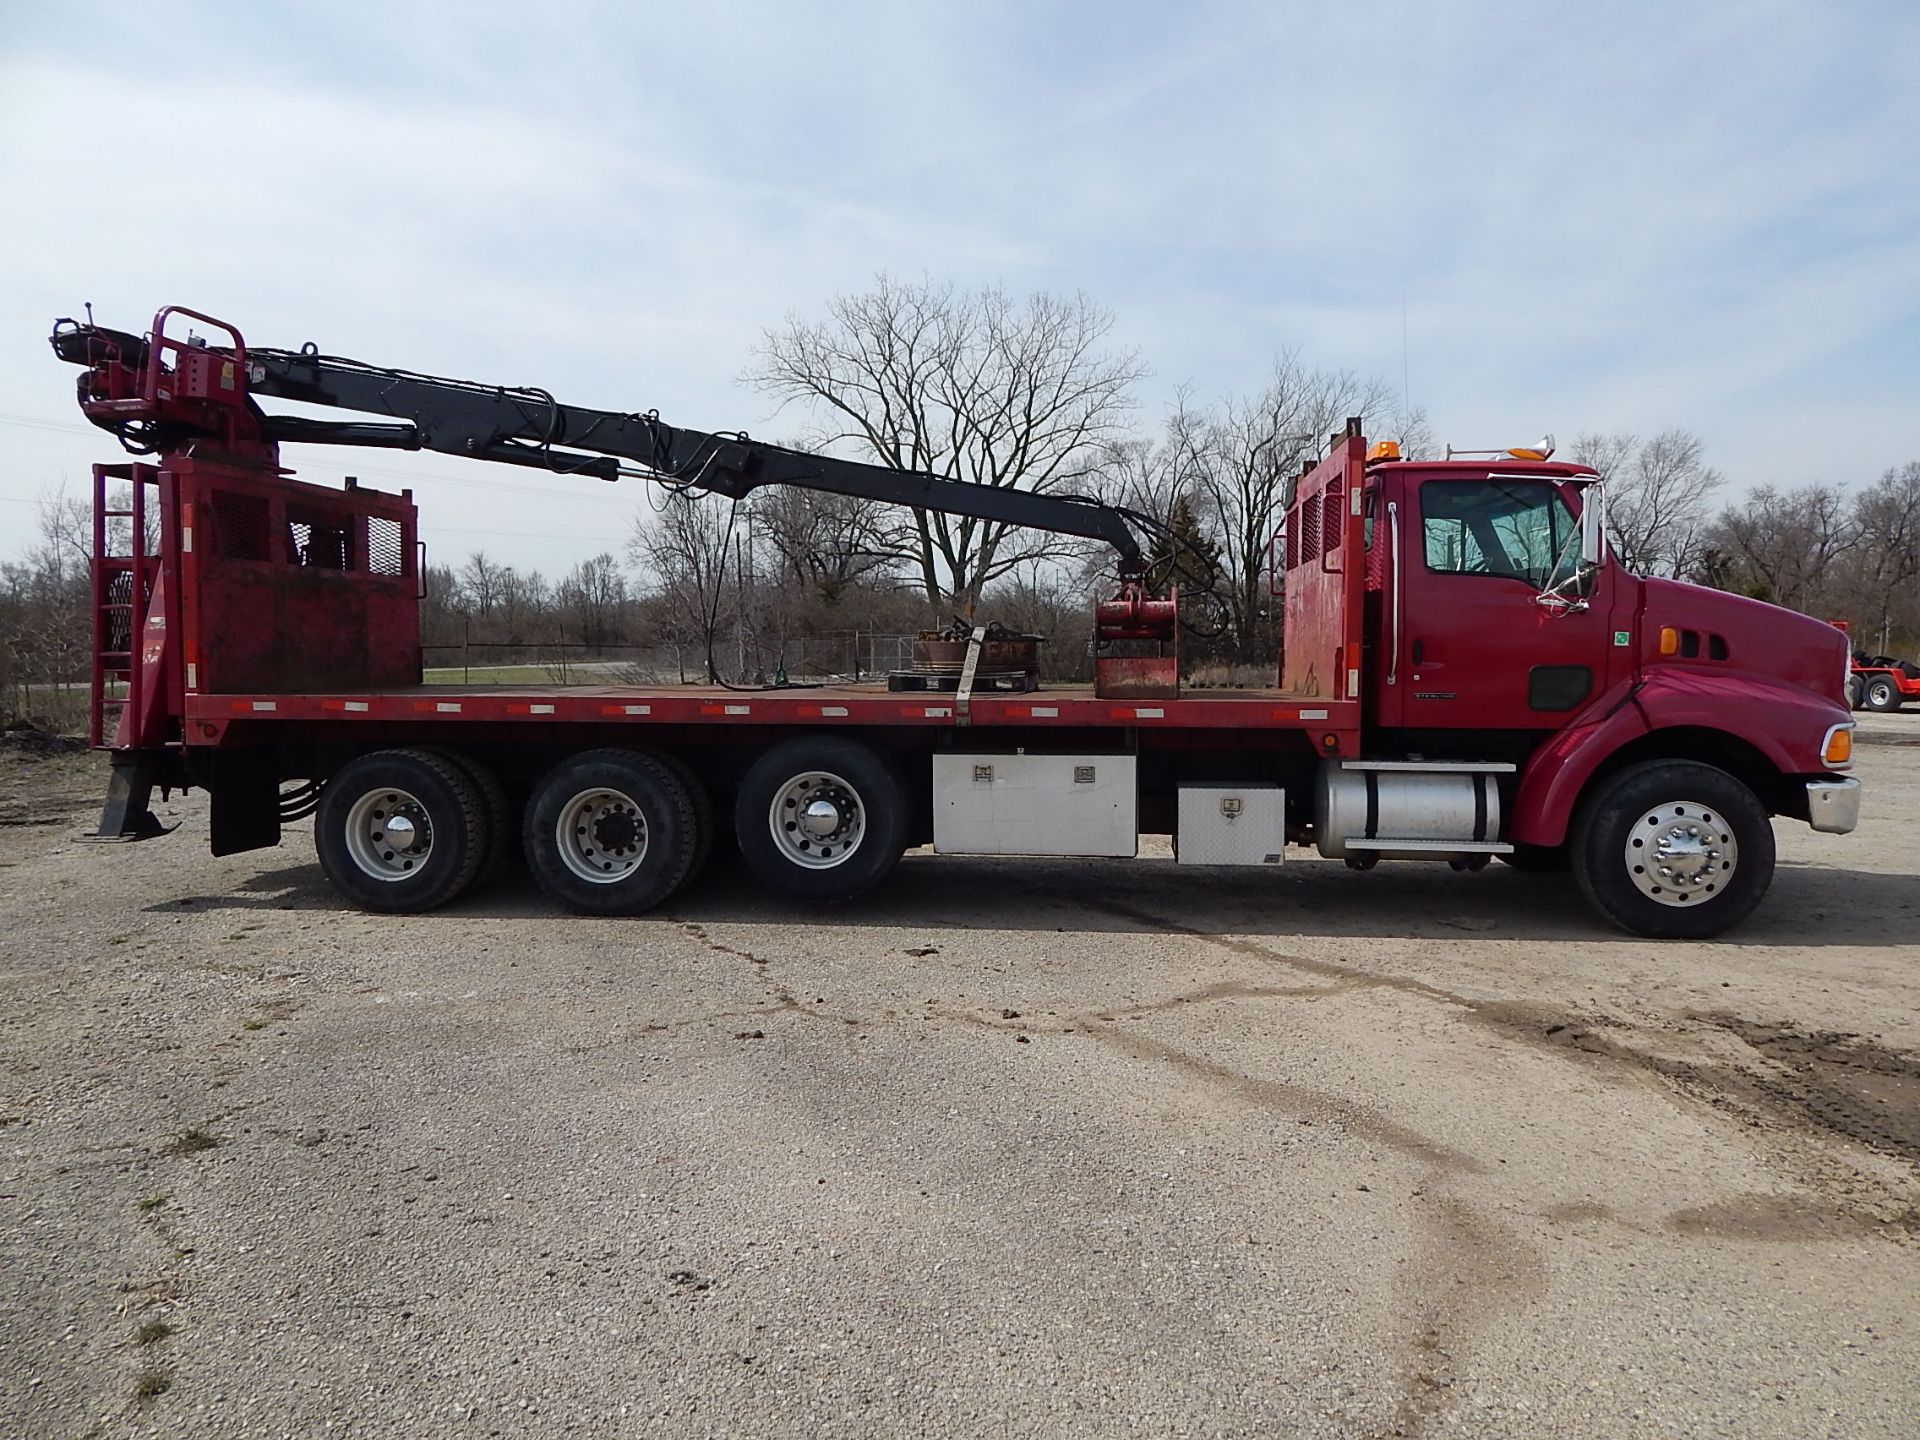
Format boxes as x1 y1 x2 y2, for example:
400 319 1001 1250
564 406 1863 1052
1571 760 1774 941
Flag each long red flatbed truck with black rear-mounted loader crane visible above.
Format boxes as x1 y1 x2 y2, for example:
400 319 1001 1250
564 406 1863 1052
52 307 1859 937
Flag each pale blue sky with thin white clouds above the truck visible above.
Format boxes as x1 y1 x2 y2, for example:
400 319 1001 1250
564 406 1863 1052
0 0 1920 572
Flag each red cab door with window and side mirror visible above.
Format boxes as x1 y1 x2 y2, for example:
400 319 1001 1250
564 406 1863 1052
1377 474 1632 732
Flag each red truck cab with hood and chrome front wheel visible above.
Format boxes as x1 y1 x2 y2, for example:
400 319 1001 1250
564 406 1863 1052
1321 445 1859 935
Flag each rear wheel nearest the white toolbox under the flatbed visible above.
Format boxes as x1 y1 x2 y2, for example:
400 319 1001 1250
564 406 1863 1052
733 735 908 904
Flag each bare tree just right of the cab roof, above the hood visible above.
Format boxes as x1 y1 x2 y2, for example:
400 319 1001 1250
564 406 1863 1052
1572 430 1722 576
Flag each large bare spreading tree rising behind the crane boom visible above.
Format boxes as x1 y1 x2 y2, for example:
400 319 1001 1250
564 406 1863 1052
747 276 1142 611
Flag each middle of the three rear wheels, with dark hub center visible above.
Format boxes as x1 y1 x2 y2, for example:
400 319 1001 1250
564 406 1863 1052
520 749 699 916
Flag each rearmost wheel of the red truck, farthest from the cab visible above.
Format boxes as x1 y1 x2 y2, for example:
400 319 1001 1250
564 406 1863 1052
313 751 490 914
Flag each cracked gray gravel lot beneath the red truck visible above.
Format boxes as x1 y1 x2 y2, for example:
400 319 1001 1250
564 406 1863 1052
0 714 1920 1440
